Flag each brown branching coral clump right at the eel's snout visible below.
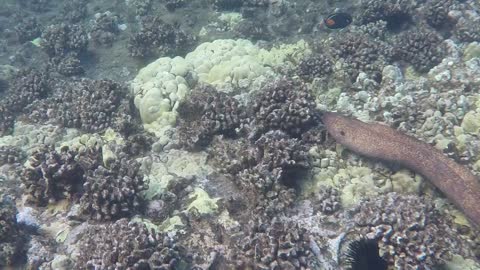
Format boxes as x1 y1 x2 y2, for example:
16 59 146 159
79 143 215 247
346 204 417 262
249 79 319 138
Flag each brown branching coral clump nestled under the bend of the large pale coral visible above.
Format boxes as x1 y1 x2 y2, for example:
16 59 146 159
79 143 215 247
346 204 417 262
178 85 246 149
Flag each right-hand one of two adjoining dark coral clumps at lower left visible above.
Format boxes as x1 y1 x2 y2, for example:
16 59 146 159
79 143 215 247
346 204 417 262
80 153 148 220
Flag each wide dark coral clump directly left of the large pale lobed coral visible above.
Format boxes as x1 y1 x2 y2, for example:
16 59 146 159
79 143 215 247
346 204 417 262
27 79 136 133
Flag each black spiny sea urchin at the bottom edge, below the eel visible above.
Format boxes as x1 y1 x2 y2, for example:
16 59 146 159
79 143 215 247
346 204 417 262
345 238 387 270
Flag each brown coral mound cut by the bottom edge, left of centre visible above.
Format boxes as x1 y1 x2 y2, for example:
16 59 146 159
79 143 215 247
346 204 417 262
77 219 187 269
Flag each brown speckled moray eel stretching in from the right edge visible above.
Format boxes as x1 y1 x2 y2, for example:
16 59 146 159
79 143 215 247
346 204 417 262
322 112 480 228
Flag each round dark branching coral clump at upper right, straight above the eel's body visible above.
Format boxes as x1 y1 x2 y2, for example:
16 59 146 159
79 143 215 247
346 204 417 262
395 29 446 72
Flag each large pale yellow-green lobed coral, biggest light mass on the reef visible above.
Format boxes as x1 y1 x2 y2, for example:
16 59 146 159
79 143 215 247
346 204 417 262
131 39 310 131
